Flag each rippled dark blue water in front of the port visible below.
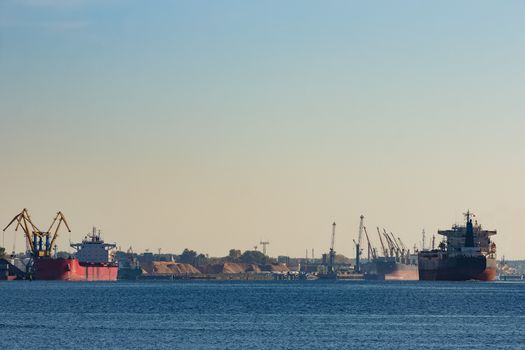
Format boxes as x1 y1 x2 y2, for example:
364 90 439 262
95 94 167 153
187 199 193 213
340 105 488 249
0 281 525 349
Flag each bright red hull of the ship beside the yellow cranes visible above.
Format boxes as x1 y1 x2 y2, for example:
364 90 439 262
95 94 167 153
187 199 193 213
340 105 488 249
33 258 118 281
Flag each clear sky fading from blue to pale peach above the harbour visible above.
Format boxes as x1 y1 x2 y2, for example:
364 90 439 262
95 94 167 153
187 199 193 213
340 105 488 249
0 0 525 259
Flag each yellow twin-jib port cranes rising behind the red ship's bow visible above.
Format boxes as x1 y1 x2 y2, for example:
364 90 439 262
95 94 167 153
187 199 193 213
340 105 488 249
3 208 71 258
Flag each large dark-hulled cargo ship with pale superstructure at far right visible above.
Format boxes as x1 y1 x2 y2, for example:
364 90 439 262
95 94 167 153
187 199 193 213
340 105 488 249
418 211 497 281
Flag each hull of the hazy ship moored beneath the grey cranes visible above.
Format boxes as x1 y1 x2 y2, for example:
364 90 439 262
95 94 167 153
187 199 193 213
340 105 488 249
363 260 419 281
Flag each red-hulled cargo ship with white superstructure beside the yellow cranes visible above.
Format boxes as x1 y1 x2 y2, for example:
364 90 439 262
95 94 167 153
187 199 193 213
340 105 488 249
32 228 118 281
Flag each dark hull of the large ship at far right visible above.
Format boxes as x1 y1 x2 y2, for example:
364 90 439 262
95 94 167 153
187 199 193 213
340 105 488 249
419 254 496 281
